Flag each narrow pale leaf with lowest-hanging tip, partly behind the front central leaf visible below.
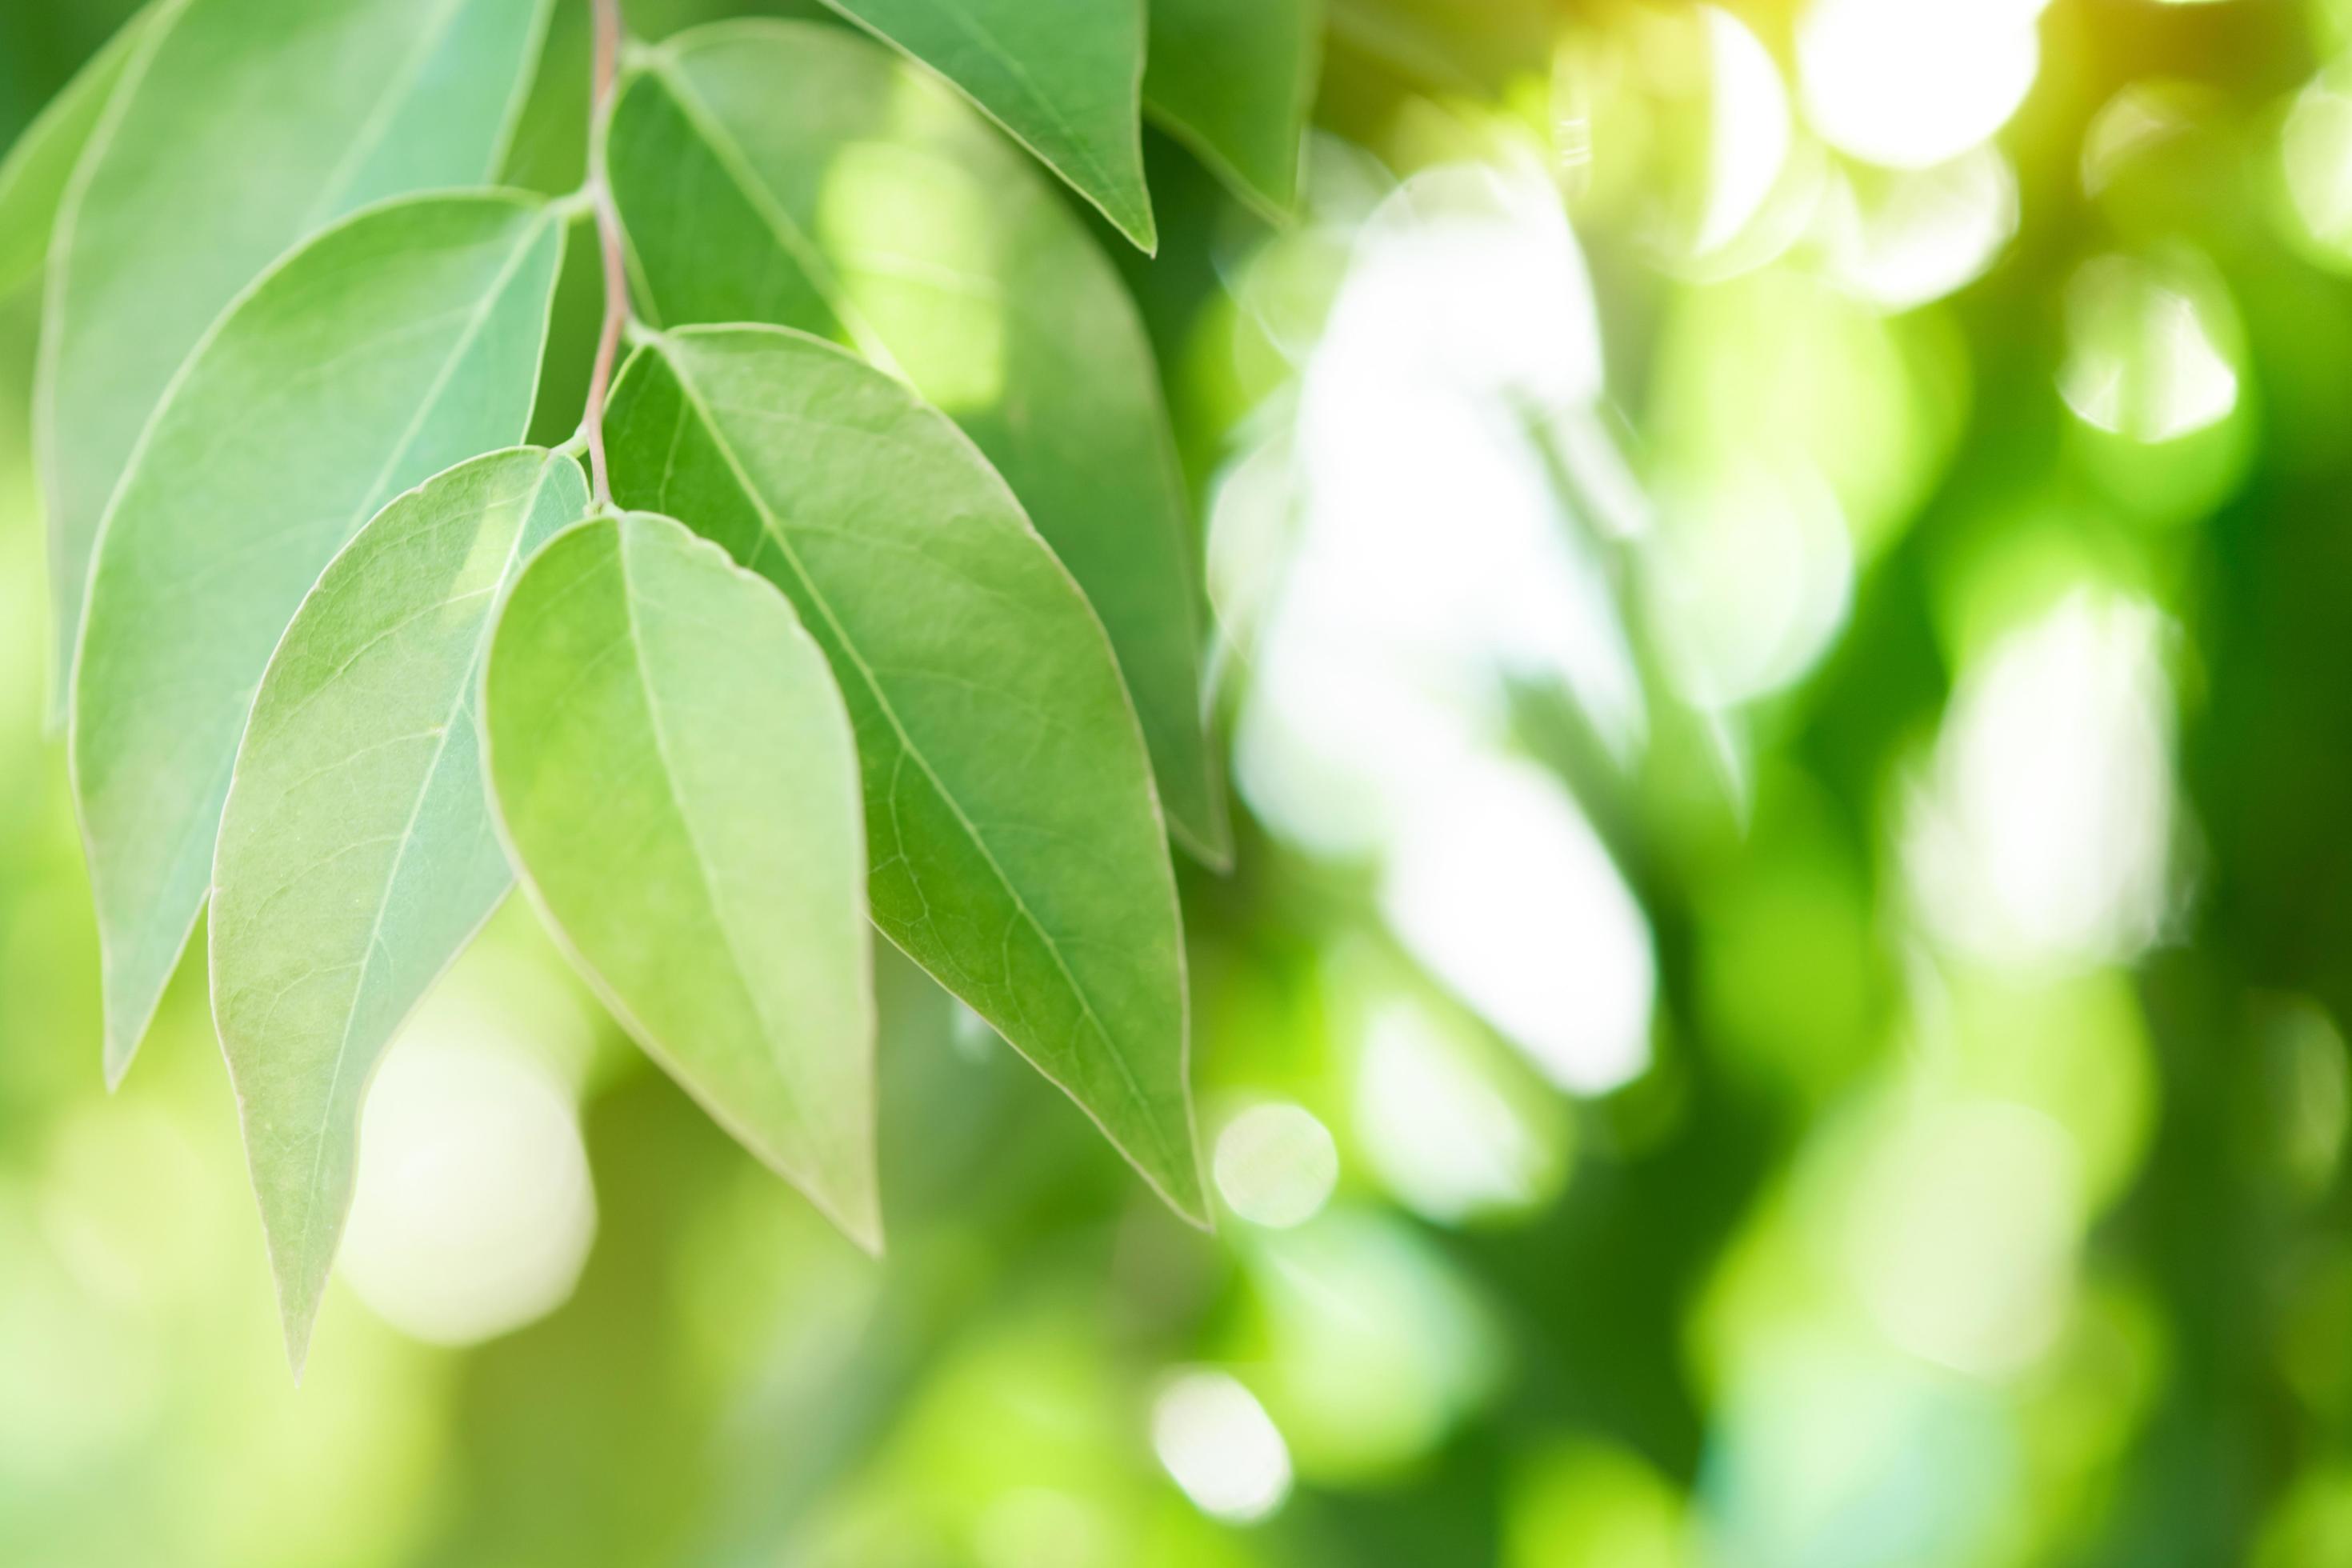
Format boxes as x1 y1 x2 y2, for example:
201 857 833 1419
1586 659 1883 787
212 449 588 1375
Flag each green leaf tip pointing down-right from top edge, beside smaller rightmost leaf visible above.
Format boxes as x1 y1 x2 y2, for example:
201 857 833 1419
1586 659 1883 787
826 0 1159 251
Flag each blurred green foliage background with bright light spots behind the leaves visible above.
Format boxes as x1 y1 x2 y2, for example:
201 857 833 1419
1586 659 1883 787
22 0 2352 1568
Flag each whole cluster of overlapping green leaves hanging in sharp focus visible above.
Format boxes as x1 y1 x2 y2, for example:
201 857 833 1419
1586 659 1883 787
0 0 1319 1368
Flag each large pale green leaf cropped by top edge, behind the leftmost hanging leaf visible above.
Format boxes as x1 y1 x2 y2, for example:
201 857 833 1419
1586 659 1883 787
33 0 548 712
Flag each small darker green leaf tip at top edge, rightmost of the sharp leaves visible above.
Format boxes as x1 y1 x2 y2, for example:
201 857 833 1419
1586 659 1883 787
1143 0 1322 218
